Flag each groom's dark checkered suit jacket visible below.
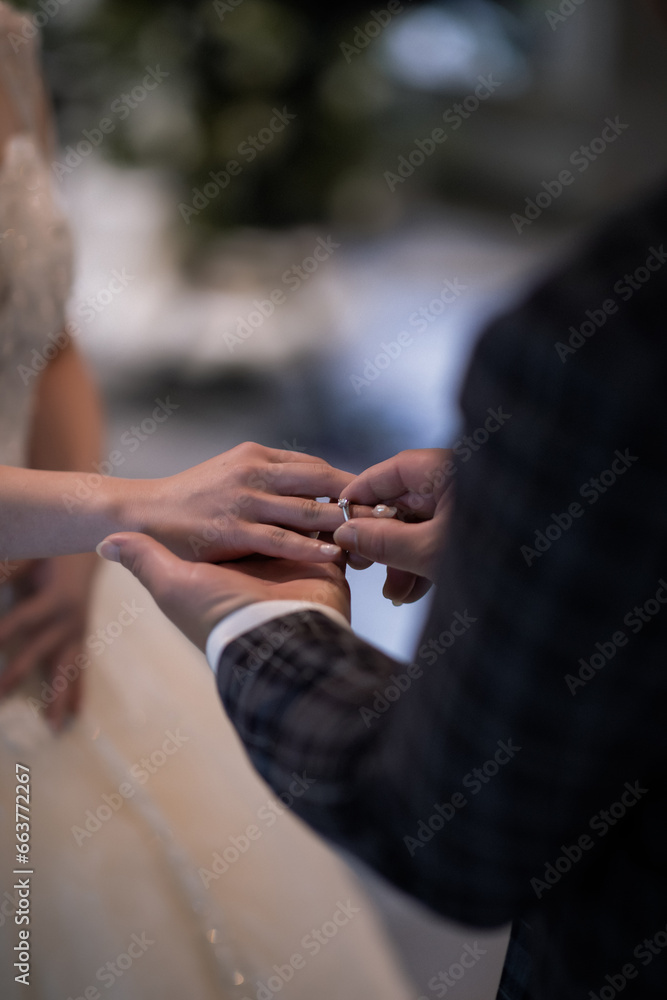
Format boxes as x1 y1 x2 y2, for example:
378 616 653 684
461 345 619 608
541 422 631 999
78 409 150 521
219 182 667 1000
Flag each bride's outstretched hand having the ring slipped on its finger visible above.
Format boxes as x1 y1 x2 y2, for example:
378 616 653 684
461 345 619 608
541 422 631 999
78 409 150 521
137 443 370 563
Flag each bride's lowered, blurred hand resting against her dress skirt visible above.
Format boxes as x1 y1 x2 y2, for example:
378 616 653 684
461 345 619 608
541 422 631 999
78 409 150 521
0 555 97 730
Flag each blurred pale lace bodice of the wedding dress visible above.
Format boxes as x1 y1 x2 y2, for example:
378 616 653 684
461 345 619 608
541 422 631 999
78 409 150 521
0 2 72 465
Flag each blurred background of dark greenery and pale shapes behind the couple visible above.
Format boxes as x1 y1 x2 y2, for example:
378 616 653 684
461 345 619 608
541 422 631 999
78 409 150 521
16 0 667 1000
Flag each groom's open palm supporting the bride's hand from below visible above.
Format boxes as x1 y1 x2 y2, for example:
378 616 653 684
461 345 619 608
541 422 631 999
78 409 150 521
98 533 350 650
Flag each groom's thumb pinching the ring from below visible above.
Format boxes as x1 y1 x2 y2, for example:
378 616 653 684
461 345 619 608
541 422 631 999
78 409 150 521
334 517 433 576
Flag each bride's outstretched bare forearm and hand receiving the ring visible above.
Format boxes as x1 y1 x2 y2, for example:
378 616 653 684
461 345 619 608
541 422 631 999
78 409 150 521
0 400 361 566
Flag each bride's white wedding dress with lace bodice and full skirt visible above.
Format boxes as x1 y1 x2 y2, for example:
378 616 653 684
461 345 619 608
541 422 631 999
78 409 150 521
0 3 414 1000
